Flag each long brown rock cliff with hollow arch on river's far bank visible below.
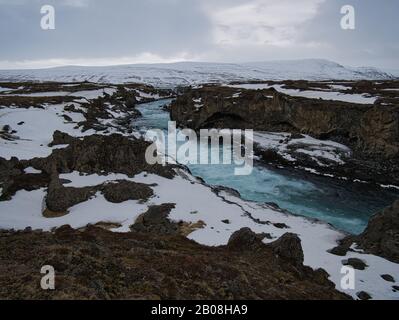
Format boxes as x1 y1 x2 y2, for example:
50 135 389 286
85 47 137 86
170 86 399 184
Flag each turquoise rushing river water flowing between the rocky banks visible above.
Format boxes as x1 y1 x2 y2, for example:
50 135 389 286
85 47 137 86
134 100 399 234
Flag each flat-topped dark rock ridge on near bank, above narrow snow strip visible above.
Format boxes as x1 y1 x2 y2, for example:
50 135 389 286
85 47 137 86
28 133 175 178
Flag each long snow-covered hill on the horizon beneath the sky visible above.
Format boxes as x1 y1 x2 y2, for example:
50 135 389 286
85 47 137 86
0 59 394 87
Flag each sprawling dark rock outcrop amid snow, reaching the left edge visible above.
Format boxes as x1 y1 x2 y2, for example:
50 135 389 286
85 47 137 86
0 131 175 217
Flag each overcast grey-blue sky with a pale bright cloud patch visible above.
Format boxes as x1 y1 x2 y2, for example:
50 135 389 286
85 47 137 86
0 0 399 69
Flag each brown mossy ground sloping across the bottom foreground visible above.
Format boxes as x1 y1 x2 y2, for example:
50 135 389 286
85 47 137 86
0 226 348 299
